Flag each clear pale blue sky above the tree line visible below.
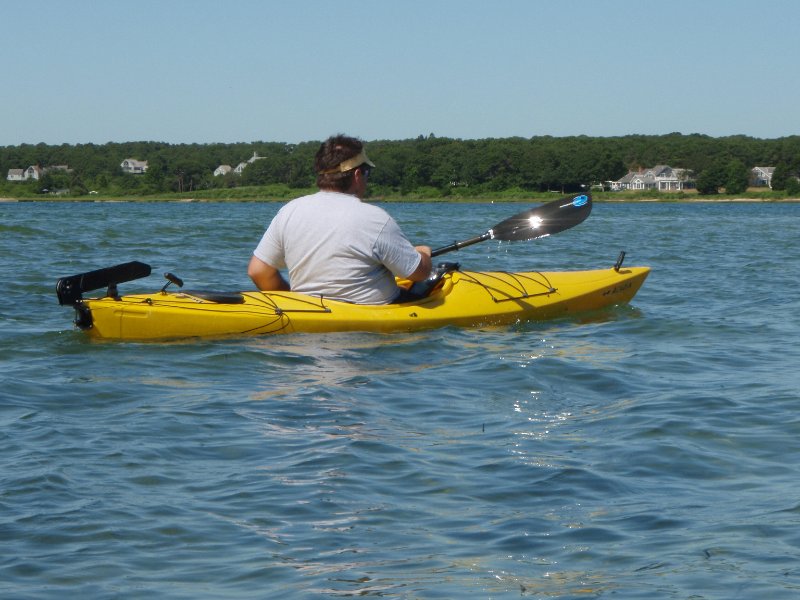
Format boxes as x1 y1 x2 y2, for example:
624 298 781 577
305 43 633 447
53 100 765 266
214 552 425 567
0 0 800 145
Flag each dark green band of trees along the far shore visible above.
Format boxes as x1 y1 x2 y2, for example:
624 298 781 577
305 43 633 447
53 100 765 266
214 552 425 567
0 133 800 198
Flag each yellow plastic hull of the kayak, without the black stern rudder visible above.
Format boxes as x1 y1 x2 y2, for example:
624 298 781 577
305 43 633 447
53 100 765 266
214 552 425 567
69 267 650 340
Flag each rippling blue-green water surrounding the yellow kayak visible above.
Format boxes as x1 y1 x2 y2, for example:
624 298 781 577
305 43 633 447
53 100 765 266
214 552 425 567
0 203 800 599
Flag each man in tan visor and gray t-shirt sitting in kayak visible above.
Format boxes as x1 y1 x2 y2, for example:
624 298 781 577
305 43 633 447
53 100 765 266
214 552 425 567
247 135 431 304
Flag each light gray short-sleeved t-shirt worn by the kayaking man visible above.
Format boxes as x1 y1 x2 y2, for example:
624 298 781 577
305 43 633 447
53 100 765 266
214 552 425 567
253 191 421 304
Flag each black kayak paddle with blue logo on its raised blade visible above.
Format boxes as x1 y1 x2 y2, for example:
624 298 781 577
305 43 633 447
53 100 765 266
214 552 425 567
431 194 592 257
